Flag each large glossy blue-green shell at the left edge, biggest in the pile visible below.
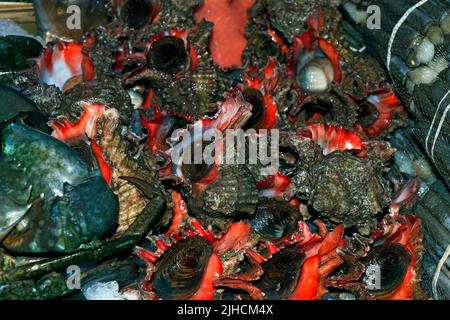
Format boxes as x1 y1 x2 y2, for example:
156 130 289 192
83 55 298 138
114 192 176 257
1 124 119 253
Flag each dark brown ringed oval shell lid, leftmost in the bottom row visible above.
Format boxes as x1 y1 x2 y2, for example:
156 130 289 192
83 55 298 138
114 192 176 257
152 236 212 300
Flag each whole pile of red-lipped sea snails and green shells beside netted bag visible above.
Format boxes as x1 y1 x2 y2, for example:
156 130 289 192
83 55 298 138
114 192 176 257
0 0 449 300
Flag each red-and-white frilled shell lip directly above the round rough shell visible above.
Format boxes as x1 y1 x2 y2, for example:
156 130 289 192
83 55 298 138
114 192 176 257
302 123 364 155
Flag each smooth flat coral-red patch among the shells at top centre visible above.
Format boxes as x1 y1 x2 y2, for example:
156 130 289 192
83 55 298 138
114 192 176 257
195 0 255 68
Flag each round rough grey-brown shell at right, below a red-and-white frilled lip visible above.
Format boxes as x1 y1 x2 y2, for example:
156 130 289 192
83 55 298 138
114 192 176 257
310 151 390 232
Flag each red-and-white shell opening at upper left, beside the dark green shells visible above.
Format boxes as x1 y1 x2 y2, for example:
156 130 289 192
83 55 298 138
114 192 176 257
37 42 95 89
